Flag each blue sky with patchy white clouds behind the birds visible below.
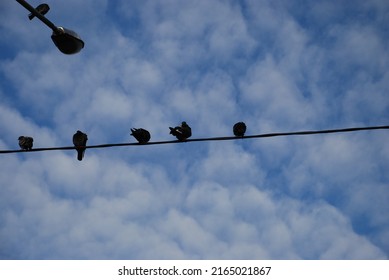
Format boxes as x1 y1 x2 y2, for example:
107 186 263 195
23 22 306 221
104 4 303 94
0 0 389 259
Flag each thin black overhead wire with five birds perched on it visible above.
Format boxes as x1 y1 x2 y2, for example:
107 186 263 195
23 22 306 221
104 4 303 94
0 125 389 154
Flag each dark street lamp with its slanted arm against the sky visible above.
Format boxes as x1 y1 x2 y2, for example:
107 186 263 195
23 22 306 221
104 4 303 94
16 0 84 54
